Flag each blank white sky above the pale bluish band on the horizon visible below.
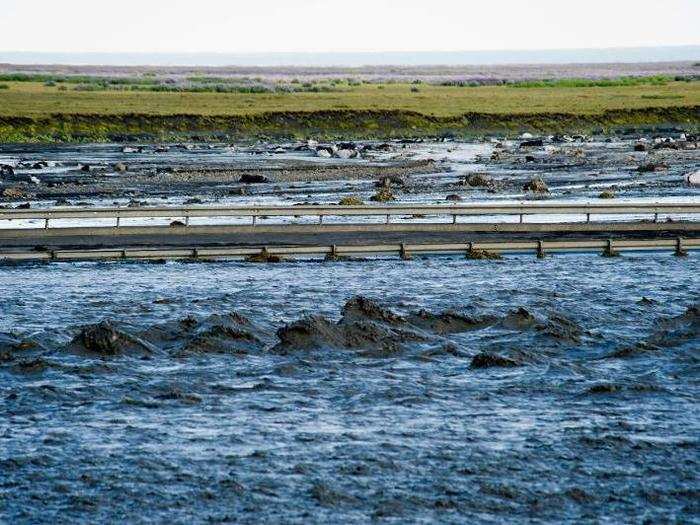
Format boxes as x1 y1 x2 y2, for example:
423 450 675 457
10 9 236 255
0 0 700 53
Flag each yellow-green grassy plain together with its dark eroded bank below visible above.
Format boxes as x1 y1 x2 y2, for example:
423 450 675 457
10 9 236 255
0 81 700 142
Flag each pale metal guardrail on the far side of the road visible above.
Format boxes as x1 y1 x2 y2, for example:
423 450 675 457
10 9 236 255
0 202 700 228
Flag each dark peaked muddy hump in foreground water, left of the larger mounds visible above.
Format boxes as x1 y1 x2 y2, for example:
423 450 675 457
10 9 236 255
69 320 153 357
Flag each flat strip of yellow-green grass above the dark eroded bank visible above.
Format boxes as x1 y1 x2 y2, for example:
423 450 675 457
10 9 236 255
0 82 700 117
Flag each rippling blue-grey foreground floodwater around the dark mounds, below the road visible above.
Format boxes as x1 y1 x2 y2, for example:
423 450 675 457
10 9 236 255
0 254 700 523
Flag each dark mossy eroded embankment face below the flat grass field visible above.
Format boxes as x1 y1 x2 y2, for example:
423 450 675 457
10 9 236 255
0 106 700 142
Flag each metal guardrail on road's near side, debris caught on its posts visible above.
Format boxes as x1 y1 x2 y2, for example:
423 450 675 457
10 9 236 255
0 238 700 262
